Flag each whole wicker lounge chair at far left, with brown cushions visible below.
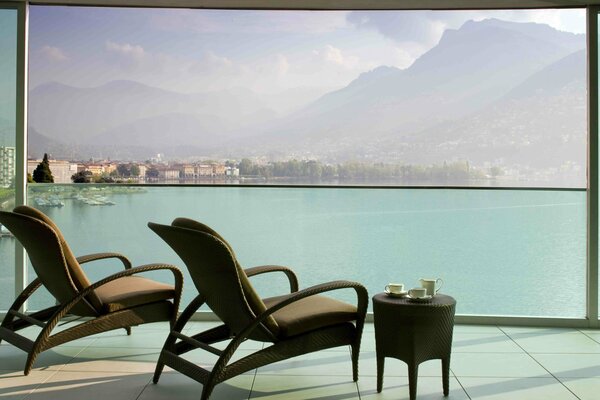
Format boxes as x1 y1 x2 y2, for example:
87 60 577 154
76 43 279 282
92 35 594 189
0 206 183 375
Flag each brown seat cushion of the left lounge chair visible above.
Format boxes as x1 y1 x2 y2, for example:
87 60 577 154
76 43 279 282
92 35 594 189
96 276 175 312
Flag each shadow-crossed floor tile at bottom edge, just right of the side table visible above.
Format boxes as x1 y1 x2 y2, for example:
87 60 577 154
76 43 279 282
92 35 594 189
458 377 577 400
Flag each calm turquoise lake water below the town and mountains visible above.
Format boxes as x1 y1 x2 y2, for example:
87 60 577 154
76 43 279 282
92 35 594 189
0 186 586 318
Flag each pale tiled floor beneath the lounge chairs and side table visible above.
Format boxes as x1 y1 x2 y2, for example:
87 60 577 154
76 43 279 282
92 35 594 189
0 322 600 400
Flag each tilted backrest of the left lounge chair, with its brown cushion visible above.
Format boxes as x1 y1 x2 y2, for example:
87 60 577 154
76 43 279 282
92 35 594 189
0 206 101 316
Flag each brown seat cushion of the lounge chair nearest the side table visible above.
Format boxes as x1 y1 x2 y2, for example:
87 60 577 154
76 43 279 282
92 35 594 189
263 294 357 338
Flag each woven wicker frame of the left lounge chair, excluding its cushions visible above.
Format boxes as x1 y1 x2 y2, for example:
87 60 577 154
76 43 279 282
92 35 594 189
0 206 183 375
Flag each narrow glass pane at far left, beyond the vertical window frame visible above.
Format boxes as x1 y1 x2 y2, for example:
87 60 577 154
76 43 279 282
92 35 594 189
0 6 17 310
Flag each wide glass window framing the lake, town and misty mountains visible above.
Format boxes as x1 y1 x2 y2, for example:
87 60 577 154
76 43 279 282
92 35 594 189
19 6 587 318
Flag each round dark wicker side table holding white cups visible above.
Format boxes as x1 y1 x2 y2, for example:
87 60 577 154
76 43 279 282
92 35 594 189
373 293 456 400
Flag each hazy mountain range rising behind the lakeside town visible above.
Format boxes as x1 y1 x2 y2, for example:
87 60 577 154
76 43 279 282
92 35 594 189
29 19 586 183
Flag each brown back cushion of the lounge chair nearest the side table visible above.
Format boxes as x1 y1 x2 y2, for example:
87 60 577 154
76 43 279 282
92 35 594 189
171 218 279 335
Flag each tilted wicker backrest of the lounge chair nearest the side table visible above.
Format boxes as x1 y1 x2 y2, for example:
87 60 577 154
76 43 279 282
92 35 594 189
148 218 278 341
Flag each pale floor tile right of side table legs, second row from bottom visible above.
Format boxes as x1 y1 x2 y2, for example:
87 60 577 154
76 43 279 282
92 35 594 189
450 353 550 381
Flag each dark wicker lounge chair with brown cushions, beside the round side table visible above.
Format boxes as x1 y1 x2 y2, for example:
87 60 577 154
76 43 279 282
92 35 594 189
148 218 369 400
